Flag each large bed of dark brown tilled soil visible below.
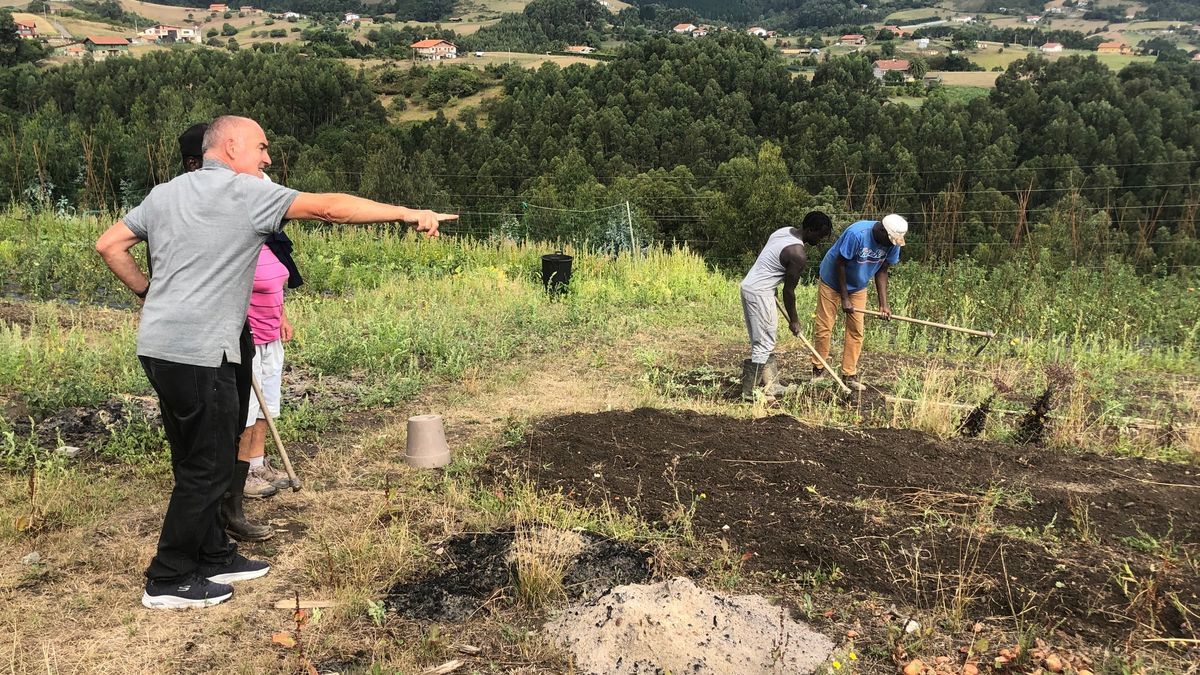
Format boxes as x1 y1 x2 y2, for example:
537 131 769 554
506 408 1200 643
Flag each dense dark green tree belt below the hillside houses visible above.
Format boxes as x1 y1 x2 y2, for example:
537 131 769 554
0 35 1200 267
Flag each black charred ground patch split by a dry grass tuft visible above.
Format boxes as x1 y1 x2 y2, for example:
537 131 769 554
385 531 650 621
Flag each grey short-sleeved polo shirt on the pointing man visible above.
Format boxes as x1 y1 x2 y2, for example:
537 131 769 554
121 160 299 368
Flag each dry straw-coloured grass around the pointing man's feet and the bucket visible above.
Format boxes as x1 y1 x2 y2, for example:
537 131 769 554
0 306 662 674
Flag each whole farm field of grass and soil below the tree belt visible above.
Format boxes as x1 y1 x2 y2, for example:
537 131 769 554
0 210 1200 674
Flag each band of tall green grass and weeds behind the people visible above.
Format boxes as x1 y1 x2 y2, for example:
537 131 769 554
0 210 1200 416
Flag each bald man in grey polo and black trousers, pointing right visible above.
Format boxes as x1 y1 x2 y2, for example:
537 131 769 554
96 117 457 609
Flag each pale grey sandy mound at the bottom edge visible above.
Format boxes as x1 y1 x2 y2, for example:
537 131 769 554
545 578 834 675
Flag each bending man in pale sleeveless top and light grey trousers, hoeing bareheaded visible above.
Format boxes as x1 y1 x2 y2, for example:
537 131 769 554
742 211 833 399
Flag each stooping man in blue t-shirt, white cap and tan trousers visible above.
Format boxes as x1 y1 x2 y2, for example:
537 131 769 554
812 214 908 392
